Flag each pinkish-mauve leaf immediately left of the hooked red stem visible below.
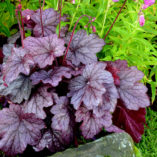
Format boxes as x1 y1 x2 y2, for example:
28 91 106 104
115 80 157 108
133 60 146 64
24 34 65 68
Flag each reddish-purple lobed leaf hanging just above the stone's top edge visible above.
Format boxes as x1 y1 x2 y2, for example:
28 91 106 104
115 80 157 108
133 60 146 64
75 107 112 139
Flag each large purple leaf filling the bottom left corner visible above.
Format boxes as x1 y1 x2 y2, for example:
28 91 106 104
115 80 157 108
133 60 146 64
0 104 45 156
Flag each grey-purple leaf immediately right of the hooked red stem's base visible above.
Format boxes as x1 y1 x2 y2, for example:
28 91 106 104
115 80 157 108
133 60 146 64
65 30 105 66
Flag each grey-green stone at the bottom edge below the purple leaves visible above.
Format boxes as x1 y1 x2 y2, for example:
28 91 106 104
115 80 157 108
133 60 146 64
50 133 136 157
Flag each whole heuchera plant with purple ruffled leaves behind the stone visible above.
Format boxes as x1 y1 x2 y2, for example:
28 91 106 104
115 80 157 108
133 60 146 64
0 0 150 156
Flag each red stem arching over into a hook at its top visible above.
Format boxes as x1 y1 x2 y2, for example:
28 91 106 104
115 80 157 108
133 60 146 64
62 15 91 64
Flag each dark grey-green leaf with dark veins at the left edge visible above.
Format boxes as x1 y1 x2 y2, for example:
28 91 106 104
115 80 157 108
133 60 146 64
0 75 32 103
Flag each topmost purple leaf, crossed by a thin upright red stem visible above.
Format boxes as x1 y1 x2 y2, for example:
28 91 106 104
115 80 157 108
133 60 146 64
31 8 66 37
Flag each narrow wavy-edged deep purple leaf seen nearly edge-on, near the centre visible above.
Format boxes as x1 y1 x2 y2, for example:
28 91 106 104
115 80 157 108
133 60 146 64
31 66 71 87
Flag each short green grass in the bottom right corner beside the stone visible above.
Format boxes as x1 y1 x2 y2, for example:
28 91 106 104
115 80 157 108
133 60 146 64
136 108 157 157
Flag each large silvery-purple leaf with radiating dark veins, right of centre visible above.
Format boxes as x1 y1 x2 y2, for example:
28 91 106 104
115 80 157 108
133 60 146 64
68 62 113 109
